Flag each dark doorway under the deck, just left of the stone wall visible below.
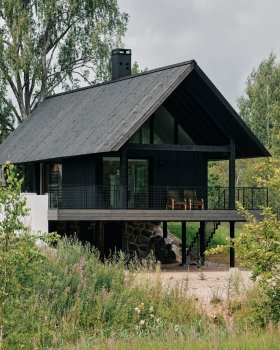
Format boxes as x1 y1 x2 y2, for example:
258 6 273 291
104 222 122 258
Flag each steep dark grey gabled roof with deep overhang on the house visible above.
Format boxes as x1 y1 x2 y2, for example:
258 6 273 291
0 61 269 163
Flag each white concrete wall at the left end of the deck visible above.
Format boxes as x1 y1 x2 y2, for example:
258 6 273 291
23 193 48 233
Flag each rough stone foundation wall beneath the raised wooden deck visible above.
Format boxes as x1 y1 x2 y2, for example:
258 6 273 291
125 222 178 264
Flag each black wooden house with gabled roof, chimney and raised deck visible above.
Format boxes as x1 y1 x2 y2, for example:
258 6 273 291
0 49 269 266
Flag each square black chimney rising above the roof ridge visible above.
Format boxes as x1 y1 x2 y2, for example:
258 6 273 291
112 49 131 80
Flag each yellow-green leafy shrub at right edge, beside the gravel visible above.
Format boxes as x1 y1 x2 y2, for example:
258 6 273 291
207 204 280 323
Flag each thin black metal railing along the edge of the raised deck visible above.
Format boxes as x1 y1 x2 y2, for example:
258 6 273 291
49 184 268 210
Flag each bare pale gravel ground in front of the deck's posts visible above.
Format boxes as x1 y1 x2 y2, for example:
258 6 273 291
138 262 253 317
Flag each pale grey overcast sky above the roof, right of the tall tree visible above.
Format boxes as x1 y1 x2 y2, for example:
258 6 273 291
118 0 280 109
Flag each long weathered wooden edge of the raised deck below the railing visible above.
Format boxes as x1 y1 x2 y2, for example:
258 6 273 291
48 209 261 222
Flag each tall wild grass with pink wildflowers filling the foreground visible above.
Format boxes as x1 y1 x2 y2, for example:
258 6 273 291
0 238 279 349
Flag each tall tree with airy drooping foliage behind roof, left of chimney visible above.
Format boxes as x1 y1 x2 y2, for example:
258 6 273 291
0 0 128 141
